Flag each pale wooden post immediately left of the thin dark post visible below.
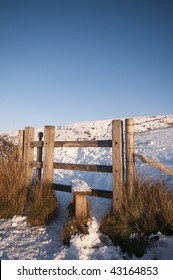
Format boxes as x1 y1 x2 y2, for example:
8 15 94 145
24 126 34 185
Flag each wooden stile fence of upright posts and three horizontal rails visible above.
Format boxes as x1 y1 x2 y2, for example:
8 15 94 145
18 119 135 212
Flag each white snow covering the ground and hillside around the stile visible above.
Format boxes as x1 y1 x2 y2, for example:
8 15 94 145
0 115 173 260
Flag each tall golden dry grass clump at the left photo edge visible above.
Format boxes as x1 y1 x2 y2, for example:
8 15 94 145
0 135 27 219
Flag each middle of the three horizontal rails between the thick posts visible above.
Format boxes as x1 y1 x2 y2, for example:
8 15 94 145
53 162 112 173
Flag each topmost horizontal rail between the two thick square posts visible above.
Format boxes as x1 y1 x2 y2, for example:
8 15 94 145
54 140 112 148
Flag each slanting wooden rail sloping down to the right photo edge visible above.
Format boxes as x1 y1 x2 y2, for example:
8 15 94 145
134 153 173 176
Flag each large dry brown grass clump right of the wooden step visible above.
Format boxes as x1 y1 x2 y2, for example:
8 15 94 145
100 180 173 256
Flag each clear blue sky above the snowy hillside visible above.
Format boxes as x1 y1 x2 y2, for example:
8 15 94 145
0 0 173 131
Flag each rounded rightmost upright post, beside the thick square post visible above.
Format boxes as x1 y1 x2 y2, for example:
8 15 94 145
125 118 135 197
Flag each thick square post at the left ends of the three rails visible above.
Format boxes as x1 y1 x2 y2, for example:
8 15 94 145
42 126 55 186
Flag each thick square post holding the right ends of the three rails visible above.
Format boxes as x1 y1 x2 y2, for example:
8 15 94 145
112 120 124 210
